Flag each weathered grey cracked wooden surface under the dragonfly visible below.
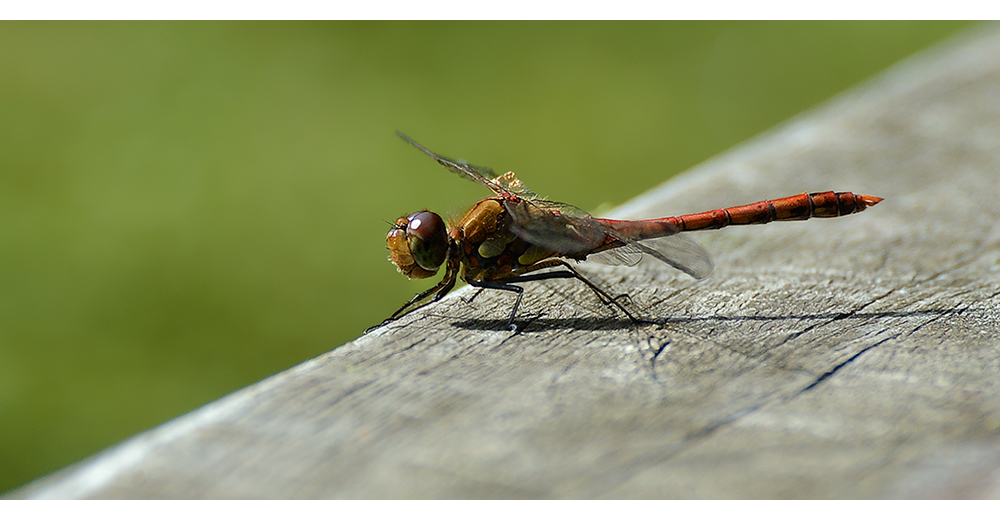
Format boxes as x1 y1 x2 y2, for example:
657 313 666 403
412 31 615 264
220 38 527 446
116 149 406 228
13 28 1000 498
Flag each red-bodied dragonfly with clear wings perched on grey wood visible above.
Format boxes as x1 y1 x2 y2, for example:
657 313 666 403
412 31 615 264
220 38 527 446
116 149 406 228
376 131 882 332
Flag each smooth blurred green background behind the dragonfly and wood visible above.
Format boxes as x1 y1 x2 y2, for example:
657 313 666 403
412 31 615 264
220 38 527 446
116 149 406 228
0 22 968 491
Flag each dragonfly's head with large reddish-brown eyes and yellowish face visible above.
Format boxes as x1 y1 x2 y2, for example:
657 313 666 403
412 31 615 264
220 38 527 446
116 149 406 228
385 210 448 279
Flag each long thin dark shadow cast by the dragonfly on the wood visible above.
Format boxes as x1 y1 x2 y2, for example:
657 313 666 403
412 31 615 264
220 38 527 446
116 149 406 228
451 309 962 332
